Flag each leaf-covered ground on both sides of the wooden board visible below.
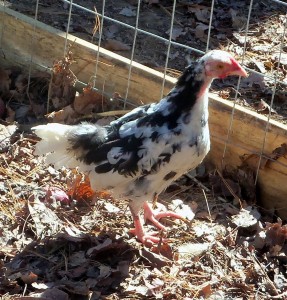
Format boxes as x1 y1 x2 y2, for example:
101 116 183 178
0 0 287 300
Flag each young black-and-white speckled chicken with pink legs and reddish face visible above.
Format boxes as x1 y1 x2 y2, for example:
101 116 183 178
33 50 247 244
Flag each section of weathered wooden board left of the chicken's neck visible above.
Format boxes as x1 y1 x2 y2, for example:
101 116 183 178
0 6 178 104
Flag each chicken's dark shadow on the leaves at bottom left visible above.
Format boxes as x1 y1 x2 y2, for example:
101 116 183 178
1 232 136 299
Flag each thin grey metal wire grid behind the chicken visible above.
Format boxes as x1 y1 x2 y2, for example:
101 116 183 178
0 0 287 184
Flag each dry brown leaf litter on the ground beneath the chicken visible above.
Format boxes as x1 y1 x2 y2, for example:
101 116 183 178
0 132 287 300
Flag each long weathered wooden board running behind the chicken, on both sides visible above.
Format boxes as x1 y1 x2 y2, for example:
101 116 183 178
0 6 287 219
